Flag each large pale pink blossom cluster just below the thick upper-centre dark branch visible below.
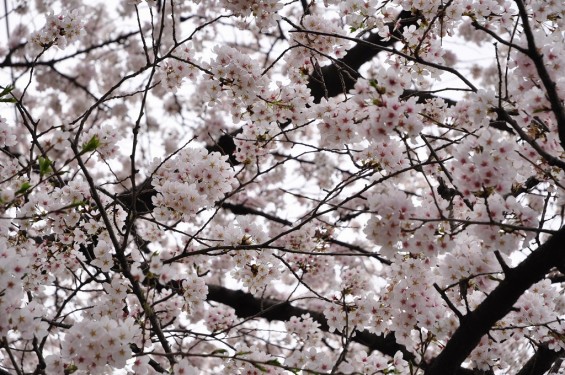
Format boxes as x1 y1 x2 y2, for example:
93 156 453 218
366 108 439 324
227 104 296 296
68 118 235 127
316 69 423 172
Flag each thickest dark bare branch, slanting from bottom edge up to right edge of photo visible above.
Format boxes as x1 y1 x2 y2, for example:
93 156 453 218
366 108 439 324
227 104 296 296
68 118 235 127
426 227 565 375
